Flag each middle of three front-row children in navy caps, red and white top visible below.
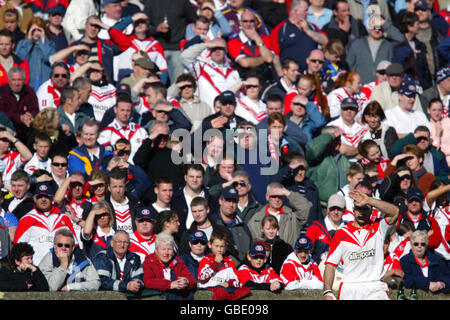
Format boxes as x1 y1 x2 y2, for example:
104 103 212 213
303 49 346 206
238 243 283 293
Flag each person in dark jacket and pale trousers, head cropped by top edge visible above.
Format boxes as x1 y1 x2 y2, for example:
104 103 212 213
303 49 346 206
143 0 196 83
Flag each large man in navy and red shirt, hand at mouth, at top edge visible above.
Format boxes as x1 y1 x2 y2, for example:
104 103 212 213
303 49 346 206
270 0 328 76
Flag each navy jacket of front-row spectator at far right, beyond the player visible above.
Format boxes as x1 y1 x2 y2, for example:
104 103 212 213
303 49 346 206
400 251 450 293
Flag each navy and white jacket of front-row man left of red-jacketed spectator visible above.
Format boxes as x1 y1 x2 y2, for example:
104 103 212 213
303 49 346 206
92 247 144 292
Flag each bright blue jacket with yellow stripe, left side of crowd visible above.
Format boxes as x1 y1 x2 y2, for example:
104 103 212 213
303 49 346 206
68 145 114 174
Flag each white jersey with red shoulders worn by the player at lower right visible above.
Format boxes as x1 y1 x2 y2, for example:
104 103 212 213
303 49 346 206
325 219 395 282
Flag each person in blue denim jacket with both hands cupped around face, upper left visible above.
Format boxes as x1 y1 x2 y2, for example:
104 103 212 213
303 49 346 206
16 17 56 90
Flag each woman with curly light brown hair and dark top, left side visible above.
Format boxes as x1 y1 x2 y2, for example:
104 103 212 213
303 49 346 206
27 107 77 154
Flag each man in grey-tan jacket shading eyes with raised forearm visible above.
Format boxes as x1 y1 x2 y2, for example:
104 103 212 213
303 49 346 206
248 183 311 246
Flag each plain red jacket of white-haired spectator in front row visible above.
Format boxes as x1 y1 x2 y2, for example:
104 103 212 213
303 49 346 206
142 253 197 291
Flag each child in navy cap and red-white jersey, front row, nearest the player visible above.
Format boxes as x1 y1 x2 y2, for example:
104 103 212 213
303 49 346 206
280 236 323 290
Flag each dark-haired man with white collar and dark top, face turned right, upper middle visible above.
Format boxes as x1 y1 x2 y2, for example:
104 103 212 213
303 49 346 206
262 58 300 102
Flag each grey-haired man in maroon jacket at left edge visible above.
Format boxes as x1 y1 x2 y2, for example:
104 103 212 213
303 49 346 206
0 66 39 141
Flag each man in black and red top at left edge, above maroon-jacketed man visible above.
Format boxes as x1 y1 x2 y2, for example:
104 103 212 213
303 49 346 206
0 30 30 86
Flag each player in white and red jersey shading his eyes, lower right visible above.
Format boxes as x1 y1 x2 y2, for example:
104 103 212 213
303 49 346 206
323 185 399 300
